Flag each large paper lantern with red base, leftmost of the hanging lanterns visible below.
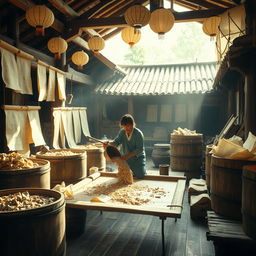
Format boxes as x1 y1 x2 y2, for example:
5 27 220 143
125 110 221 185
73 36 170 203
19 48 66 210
26 5 54 36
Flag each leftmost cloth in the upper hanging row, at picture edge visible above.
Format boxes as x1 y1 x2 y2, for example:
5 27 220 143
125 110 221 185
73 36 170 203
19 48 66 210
0 47 20 92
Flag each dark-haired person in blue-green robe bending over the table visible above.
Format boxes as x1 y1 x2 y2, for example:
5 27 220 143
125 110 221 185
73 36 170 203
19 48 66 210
105 114 146 179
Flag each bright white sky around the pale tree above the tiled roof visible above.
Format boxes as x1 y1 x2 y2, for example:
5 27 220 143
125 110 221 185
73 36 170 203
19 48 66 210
101 2 216 64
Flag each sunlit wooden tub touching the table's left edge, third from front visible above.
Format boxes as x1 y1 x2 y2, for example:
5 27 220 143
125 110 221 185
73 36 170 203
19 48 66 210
36 149 87 187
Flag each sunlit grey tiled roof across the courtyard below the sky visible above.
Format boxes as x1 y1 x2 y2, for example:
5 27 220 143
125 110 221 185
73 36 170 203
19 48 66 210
95 62 216 95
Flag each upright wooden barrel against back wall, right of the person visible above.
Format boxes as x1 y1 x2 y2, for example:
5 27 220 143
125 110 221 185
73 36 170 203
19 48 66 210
171 134 203 179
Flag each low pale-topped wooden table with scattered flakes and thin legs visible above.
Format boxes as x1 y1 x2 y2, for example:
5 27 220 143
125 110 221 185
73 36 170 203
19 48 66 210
66 172 186 255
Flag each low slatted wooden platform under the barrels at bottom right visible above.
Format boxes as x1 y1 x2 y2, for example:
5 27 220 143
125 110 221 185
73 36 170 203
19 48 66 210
206 211 256 256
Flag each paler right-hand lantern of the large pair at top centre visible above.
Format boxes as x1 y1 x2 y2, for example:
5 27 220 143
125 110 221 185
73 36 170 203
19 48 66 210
149 8 175 36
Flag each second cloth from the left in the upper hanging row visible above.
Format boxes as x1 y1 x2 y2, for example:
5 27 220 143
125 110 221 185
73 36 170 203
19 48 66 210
17 55 33 95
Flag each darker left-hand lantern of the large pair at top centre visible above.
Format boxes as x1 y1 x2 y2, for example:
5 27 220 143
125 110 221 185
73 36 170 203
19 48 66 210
124 4 150 28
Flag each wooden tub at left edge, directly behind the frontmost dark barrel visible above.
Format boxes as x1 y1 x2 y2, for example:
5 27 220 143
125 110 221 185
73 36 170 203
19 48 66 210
0 159 51 189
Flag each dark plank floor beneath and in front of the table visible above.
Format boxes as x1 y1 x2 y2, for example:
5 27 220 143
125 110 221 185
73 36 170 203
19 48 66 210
67 189 214 256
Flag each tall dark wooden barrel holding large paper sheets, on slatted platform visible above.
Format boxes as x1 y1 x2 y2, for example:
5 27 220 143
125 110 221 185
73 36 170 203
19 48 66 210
211 155 255 220
